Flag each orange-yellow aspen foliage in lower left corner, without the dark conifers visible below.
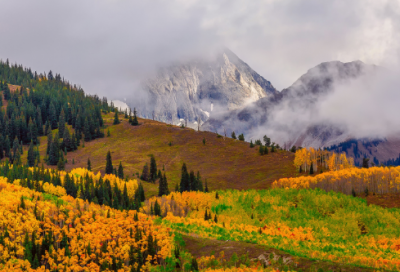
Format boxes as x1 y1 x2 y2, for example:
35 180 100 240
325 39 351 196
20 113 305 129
0 171 173 271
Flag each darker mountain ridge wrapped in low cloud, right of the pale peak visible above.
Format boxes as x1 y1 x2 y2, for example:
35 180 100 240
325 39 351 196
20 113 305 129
203 61 374 144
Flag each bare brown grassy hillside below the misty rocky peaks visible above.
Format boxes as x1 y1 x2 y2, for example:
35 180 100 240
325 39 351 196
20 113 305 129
22 111 298 195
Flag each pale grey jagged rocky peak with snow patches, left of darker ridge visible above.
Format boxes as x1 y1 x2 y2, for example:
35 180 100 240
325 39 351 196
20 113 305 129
127 49 277 124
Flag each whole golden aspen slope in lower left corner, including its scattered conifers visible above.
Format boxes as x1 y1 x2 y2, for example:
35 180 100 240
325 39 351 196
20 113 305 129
0 177 173 271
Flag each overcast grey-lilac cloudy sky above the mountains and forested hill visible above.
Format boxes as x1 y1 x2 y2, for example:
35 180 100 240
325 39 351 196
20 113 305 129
0 0 400 98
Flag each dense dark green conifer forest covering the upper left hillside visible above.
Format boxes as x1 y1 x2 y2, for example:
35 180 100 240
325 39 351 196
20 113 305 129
0 58 114 158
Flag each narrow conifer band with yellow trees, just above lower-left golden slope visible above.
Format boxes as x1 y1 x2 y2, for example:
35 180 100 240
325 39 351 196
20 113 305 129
0 160 145 210
